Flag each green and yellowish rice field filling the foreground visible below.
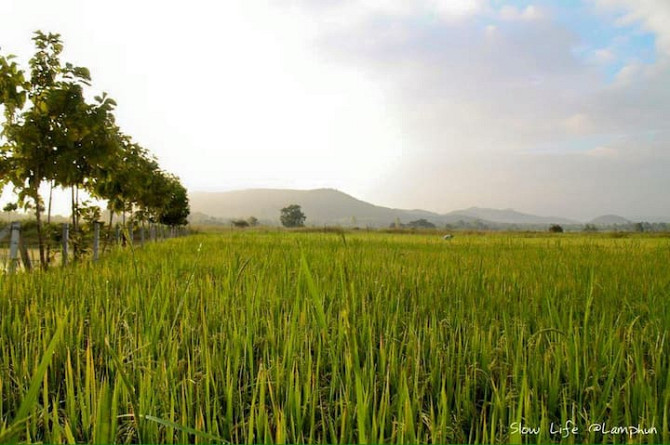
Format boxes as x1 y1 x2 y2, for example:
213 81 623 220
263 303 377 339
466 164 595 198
0 231 670 443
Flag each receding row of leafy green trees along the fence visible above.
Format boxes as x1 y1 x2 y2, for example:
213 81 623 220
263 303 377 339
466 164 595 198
0 31 189 268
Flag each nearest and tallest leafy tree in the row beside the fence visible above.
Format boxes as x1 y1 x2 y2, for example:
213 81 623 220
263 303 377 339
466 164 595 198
0 31 100 269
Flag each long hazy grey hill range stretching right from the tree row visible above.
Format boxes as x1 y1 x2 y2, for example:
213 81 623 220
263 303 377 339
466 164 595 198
189 189 579 228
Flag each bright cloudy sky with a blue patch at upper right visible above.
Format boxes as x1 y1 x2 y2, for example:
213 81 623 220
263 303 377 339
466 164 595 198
0 0 670 220
